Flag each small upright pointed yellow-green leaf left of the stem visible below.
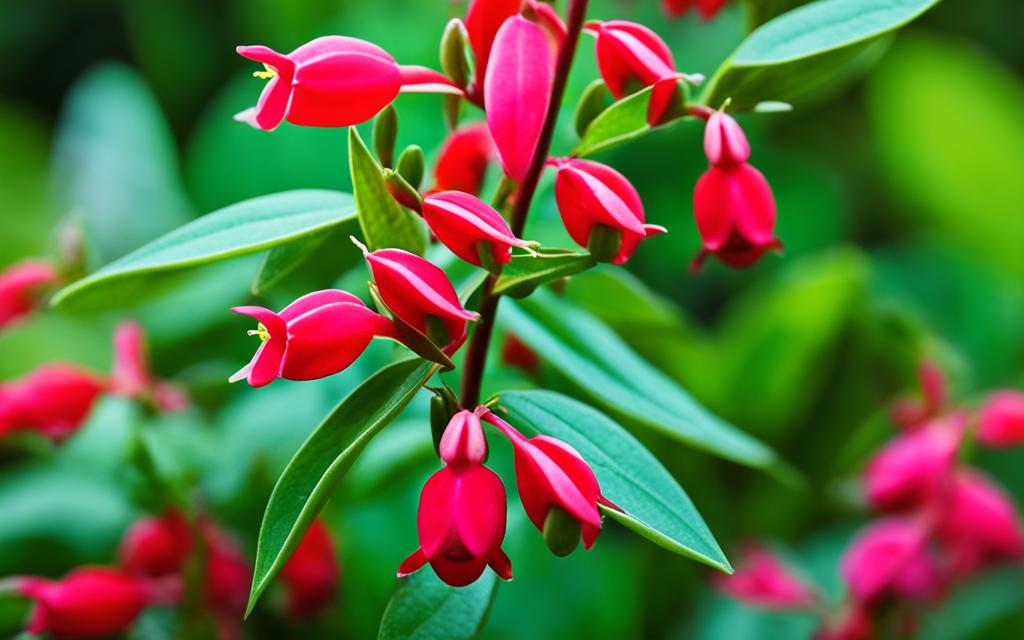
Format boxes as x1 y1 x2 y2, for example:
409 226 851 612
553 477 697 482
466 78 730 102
348 127 427 255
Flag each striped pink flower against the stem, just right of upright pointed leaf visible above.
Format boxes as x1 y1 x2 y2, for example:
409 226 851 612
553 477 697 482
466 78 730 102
423 191 535 266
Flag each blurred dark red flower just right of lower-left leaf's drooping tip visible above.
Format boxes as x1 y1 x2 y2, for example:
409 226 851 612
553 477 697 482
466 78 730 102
281 519 338 618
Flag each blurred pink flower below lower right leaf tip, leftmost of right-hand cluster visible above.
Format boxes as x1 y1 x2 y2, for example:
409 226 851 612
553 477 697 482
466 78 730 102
715 547 816 609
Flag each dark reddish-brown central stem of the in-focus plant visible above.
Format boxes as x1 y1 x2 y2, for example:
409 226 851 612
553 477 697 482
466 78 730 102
462 0 588 410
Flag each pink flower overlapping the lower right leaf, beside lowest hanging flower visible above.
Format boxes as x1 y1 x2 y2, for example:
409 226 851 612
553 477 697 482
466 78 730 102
481 412 614 555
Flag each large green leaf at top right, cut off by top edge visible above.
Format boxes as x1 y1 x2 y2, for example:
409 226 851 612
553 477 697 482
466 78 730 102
701 0 939 111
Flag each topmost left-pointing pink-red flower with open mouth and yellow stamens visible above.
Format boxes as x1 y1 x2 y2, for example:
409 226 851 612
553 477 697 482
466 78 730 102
236 36 461 131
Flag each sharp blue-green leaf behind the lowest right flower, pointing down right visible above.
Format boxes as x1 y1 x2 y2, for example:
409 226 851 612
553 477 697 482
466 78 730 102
499 391 732 572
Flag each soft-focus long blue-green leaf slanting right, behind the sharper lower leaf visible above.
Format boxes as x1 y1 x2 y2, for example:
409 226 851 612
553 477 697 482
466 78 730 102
501 291 782 471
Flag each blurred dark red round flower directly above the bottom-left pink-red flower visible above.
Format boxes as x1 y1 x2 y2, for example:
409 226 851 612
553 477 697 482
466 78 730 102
120 509 193 578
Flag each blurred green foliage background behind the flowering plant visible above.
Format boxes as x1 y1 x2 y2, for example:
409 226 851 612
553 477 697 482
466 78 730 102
0 0 1024 639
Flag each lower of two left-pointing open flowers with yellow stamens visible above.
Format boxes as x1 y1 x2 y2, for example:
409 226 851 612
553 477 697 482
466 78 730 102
231 289 394 387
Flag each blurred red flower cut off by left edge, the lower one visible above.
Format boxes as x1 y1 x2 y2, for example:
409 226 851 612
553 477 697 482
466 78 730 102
0 362 106 441
